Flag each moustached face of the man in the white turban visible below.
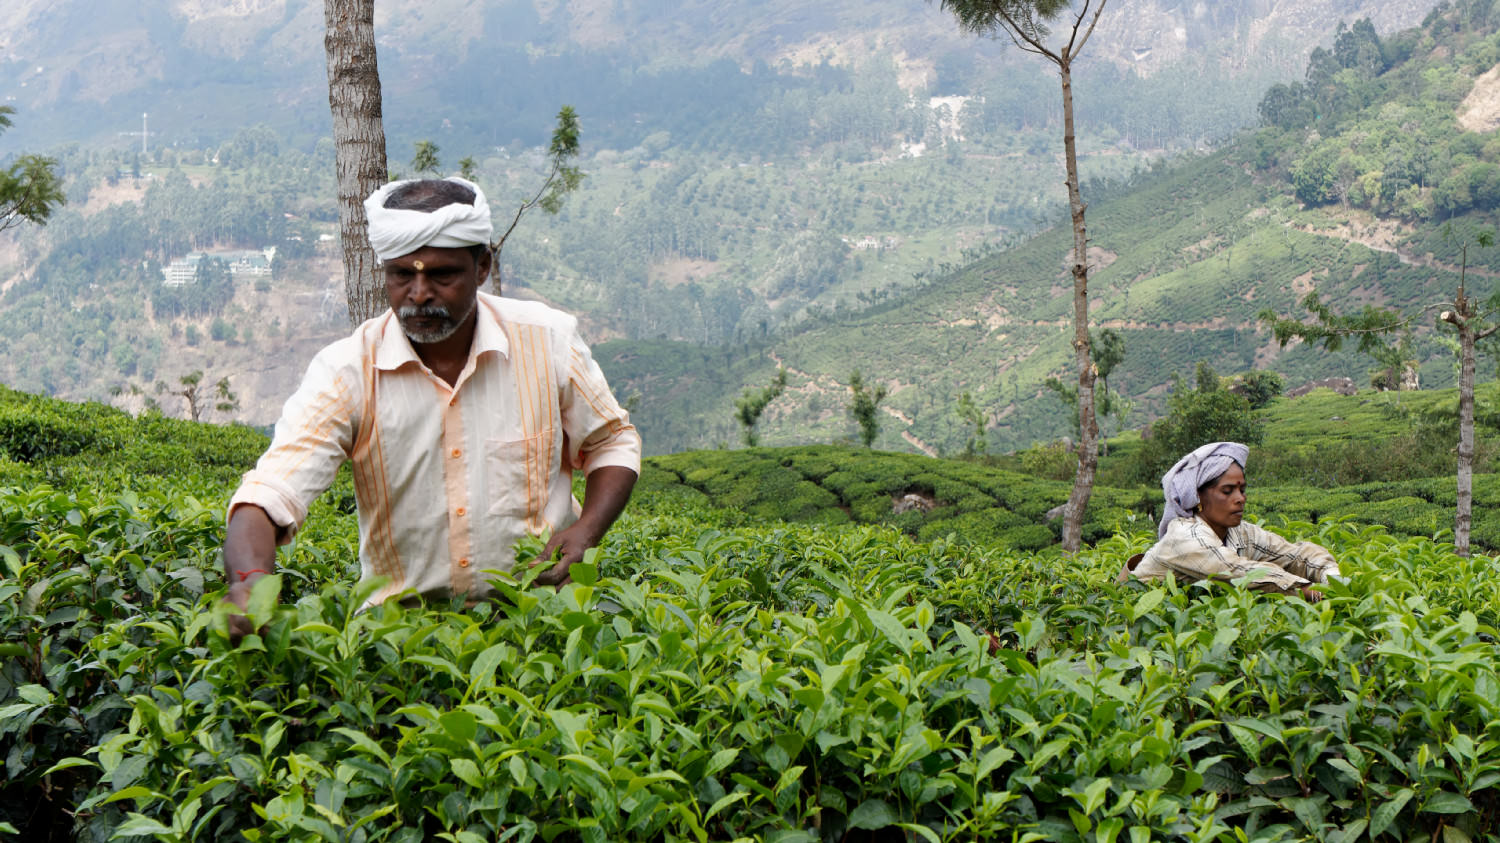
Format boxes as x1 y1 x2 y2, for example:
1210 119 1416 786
384 246 489 344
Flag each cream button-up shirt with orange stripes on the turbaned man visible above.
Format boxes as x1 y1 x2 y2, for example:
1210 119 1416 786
230 293 641 605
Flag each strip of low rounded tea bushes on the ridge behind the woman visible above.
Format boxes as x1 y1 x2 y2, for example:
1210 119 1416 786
641 446 1500 551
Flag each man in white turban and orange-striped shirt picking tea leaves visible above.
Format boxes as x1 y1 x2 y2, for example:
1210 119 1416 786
224 179 641 627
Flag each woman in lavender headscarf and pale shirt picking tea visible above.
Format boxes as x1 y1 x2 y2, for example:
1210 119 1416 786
1127 443 1338 603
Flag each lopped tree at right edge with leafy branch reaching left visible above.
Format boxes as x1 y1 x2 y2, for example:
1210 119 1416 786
1260 224 1500 557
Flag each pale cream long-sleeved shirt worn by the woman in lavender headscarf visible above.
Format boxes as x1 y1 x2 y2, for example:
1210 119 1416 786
1133 516 1338 594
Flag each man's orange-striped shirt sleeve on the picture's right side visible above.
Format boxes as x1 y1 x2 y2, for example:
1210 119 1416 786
561 333 641 474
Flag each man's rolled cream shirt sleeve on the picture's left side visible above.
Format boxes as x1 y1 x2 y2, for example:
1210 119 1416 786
227 347 360 543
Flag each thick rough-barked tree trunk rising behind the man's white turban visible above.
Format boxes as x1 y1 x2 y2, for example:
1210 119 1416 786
323 0 387 324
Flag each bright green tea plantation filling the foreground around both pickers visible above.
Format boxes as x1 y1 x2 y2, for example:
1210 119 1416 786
0 392 1500 843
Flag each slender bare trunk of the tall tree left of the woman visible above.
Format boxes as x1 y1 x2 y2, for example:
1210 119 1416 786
1058 53 1100 554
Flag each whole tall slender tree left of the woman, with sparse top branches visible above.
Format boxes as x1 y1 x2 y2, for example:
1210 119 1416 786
939 0 1107 552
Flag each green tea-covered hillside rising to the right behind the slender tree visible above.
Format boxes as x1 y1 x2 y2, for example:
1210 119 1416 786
609 4 1500 453
